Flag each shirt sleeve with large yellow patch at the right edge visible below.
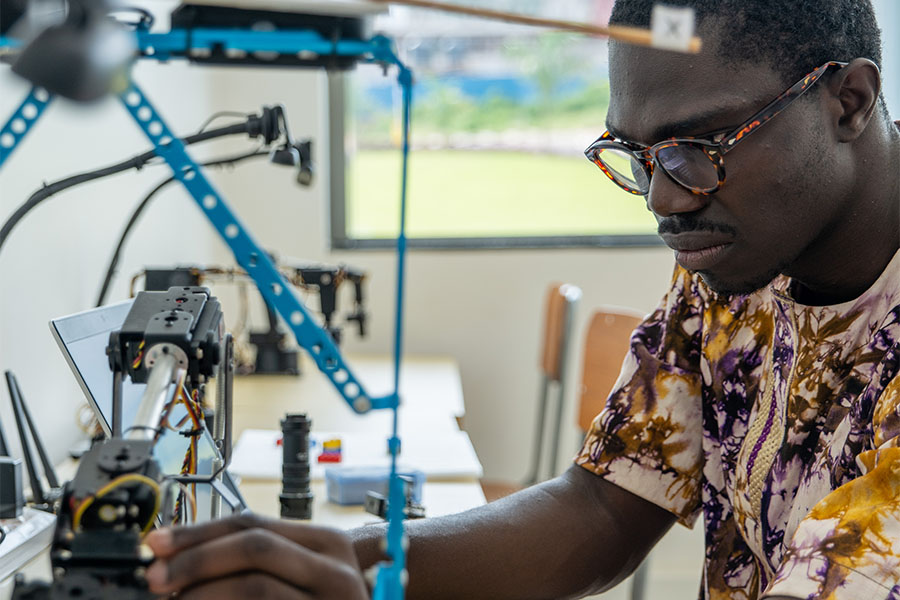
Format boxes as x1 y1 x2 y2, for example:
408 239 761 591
763 370 900 600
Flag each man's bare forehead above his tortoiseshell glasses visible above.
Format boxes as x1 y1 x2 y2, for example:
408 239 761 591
607 42 783 144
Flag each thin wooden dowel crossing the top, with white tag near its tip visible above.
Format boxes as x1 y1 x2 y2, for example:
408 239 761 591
373 0 702 54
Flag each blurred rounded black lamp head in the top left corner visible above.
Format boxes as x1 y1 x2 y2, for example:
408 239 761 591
12 0 137 102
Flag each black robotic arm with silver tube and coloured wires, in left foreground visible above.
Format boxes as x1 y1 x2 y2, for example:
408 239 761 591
13 287 236 600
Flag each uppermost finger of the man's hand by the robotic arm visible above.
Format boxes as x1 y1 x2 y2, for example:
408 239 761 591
146 513 352 560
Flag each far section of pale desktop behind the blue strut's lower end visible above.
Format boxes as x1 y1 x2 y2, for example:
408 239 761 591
233 354 466 441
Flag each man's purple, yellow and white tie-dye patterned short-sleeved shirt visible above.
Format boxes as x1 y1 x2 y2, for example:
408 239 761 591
576 252 900 600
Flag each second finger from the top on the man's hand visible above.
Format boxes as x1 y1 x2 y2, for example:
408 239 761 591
147 528 365 598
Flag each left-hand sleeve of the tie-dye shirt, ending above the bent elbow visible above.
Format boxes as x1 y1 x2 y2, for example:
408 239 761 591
575 267 705 527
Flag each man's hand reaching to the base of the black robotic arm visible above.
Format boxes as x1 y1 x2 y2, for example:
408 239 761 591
147 515 369 600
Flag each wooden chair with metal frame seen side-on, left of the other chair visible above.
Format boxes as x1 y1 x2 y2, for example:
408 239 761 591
481 283 581 502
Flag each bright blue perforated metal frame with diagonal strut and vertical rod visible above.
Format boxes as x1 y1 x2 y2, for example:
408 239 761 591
0 28 412 600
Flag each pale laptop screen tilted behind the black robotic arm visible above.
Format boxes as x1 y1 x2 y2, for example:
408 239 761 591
50 300 240 519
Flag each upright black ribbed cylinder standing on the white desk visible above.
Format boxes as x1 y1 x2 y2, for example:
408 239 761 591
279 414 313 519
